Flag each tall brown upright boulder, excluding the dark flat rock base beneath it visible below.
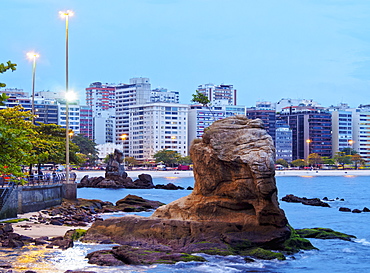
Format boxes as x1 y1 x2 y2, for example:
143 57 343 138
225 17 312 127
153 113 287 228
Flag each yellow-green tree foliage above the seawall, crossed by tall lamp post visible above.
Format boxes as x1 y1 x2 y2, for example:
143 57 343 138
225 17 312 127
0 106 81 180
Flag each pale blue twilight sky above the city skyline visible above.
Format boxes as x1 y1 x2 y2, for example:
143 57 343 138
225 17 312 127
0 0 370 107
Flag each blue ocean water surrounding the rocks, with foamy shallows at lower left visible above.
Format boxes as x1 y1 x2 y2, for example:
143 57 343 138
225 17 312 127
0 176 370 273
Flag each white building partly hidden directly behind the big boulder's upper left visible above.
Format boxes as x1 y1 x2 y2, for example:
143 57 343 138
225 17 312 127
188 104 246 143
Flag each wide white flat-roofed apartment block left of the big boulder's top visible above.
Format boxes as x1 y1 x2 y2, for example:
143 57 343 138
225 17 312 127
128 102 188 161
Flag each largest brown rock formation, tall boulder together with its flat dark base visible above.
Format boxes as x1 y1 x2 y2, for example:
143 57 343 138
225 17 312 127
85 116 291 262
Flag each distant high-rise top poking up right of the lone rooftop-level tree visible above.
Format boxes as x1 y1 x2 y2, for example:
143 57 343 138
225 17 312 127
197 83 236 106
